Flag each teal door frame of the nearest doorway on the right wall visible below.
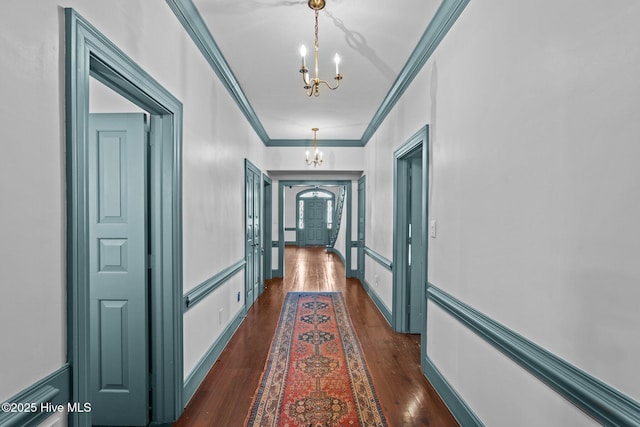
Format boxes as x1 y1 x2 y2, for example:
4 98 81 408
391 125 429 334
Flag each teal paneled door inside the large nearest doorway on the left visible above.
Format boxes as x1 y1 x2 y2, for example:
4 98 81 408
87 113 149 426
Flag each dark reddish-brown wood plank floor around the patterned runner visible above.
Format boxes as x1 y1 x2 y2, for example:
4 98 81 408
174 246 458 427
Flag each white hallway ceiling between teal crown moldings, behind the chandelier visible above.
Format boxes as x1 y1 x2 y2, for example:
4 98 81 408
188 0 440 140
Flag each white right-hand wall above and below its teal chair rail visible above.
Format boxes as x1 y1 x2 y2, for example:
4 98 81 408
365 0 640 426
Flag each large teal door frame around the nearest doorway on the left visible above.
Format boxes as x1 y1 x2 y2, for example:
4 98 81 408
64 8 184 426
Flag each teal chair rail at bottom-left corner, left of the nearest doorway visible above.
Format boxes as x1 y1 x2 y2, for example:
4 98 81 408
0 364 71 427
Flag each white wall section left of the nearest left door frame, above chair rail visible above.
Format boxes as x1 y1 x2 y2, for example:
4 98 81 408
0 2 66 401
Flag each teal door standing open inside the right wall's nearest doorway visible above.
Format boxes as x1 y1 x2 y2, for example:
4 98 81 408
407 152 426 334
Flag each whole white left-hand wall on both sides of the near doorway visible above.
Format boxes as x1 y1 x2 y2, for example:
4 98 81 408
0 0 266 401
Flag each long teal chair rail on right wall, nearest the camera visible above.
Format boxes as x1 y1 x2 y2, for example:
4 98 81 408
427 284 640 427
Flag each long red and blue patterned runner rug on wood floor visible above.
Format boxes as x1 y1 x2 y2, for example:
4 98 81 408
245 292 387 427
